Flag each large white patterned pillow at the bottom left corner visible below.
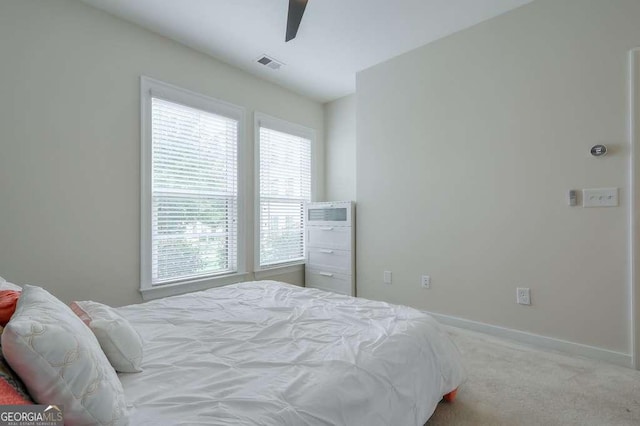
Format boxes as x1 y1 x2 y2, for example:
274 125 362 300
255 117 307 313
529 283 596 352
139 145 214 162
2 285 128 426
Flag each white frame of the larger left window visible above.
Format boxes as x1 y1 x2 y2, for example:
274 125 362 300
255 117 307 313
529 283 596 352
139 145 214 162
140 76 248 300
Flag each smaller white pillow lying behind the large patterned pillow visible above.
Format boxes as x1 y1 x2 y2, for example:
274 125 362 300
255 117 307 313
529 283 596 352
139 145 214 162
71 301 142 373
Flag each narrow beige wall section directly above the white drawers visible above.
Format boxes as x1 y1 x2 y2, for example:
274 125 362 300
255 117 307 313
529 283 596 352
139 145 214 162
324 95 356 201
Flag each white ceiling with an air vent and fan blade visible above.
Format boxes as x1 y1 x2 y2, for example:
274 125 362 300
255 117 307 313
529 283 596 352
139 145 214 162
82 0 532 102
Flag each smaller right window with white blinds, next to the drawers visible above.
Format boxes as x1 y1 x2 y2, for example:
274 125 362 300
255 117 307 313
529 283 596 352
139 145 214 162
256 114 313 269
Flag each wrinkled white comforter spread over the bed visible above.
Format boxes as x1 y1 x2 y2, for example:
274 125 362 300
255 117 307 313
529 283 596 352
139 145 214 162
118 281 464 426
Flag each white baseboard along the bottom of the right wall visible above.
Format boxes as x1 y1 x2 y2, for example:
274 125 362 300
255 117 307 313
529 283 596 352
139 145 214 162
425 311 633 368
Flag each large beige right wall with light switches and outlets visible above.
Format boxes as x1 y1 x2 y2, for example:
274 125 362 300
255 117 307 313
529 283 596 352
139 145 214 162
358 0 640 354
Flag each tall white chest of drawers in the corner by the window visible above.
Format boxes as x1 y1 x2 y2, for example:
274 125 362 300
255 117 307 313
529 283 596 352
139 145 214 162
304 201 356 296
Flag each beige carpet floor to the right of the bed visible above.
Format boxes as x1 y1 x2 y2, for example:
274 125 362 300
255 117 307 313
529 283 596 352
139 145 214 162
427 327 640 426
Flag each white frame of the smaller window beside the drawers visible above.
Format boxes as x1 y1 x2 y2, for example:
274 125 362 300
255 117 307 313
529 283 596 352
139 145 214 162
253 111 318 272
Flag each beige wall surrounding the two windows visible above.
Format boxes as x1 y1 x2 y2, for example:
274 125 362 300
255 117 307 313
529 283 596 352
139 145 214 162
0 0 324 305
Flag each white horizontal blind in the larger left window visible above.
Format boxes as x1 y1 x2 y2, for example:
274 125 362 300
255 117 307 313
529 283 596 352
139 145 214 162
151 97 238 285
